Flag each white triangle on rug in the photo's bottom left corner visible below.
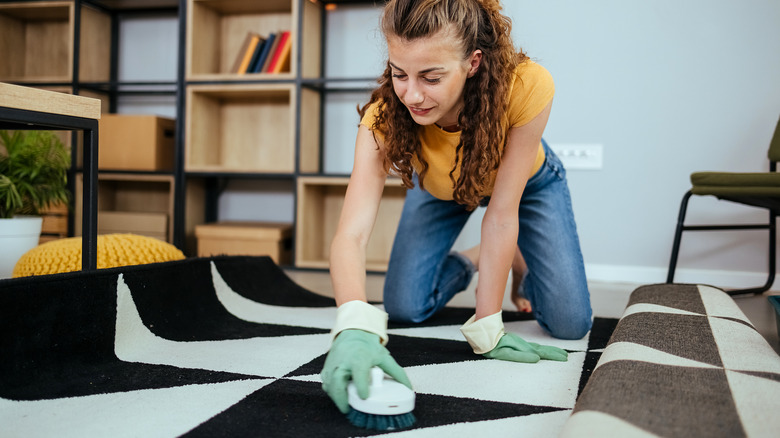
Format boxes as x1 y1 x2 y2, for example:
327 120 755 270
0 379 273 438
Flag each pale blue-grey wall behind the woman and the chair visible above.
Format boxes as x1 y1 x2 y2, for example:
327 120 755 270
325 0 780 286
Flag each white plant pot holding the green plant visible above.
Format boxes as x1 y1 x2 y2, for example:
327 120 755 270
0 216 43 278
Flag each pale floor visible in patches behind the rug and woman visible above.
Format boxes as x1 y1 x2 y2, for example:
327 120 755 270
287 270 780 354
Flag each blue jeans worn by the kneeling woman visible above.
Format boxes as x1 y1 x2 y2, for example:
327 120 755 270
384 142 592 339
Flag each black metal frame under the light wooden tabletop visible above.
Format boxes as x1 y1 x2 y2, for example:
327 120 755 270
0 106 98 271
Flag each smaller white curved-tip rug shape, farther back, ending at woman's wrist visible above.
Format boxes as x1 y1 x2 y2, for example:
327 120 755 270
211 261 336 330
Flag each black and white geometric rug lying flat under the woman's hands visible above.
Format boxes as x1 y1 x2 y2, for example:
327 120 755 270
0 257 617 438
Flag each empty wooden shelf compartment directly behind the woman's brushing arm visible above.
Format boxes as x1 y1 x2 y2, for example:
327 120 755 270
295 176 406 271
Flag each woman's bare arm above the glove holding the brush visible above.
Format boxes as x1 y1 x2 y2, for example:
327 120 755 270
330 125 387 306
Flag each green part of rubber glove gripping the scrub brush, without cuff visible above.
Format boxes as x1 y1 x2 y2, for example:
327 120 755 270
320 329 412 414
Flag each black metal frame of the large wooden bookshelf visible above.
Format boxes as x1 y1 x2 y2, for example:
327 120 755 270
0 0 384 268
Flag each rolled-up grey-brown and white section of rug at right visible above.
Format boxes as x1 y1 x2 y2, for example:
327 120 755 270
562 284 780 437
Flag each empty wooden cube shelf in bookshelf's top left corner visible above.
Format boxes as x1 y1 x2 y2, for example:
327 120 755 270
0 1 111 83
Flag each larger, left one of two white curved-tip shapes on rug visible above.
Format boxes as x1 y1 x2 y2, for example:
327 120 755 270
114 274 330 377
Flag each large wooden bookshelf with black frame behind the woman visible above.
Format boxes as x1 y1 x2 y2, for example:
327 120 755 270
6 0 405 270
